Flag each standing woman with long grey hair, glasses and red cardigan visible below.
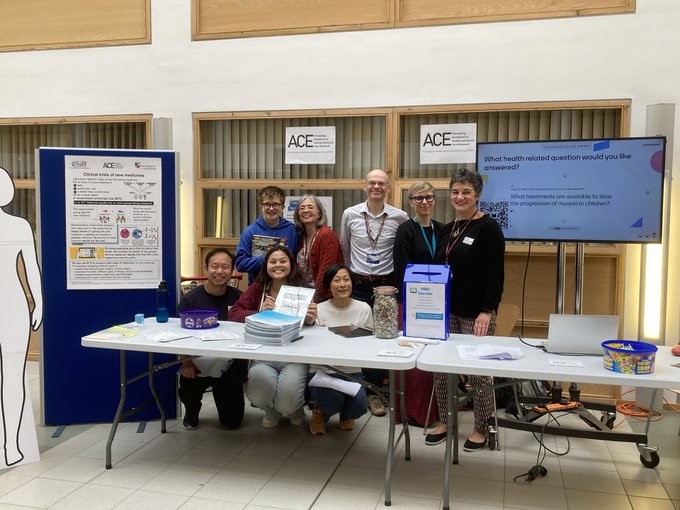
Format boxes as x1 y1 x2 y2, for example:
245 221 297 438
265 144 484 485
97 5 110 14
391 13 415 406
293 195 344 303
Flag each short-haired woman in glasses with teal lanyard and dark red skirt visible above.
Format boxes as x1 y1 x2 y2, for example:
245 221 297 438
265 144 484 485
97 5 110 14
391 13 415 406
394 181 443 426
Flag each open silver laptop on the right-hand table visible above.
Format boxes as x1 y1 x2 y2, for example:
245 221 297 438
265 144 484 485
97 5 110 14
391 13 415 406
545 313 619 356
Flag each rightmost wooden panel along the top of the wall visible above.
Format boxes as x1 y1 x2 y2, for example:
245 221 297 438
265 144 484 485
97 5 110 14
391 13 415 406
396 0 635 26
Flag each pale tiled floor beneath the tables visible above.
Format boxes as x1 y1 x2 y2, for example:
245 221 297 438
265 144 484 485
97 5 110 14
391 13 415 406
0 364 680 510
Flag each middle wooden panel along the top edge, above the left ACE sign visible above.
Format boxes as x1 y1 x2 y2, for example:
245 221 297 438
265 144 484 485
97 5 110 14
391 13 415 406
192 0 394 39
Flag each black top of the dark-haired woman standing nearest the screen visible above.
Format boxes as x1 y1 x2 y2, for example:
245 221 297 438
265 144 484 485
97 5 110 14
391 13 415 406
437 214 505 318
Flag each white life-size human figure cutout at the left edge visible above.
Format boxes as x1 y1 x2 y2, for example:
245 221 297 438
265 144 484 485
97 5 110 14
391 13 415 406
0 167 43 469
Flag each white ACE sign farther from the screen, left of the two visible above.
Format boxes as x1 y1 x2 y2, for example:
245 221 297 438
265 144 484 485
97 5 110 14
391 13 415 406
285 126 335 165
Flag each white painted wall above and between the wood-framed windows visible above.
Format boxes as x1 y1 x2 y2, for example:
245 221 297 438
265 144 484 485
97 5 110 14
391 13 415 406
0 0 680 343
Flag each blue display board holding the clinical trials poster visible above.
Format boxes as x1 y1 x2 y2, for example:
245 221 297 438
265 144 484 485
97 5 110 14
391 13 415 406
37 148 179 425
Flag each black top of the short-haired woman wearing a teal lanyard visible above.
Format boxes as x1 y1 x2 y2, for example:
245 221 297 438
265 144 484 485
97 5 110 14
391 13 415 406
394 219 444 284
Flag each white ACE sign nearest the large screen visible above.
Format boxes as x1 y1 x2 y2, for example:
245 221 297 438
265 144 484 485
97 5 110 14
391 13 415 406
420 123 477 165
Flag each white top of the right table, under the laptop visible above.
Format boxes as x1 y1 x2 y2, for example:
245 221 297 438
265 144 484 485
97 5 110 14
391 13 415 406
417 335 680 389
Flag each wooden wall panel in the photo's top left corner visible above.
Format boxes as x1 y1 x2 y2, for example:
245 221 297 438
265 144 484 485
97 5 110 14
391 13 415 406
0 0 151 51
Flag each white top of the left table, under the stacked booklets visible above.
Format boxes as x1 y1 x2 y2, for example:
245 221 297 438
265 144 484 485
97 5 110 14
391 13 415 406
81 318 423 370
